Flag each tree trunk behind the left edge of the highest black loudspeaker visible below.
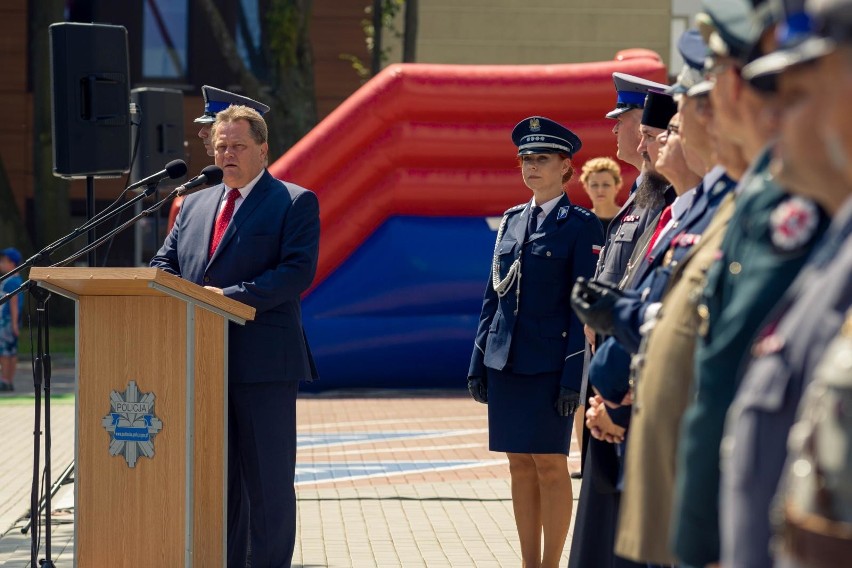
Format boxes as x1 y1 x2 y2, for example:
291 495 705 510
29 0 71 249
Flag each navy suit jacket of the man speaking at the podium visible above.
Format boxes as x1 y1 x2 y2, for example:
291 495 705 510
150 171 320 383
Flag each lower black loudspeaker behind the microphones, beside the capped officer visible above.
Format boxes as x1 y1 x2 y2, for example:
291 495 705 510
130 87 184 185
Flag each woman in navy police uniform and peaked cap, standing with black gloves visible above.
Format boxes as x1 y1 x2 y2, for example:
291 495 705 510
468 116 603 568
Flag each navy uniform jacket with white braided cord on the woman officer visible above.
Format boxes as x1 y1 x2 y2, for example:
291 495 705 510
468 195 603 392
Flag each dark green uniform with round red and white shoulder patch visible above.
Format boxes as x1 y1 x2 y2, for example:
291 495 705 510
672 148 827 566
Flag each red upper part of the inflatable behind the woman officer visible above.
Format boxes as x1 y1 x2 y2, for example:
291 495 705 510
269 49 666 286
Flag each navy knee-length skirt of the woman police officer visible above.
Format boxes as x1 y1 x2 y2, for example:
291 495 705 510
487 369 573 455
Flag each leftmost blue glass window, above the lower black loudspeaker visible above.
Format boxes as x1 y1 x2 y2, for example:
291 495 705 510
142 0 189 79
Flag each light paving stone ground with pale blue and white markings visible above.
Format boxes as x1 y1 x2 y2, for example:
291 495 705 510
0 360 579 568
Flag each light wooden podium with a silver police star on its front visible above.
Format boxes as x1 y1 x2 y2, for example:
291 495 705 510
30 268 254 568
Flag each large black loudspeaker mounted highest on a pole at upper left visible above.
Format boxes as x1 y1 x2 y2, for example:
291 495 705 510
49 22 130 178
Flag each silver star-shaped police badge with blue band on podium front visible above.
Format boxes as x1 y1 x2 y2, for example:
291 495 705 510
101 381 163 467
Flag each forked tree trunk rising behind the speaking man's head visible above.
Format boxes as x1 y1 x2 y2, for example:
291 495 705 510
195 0 317 156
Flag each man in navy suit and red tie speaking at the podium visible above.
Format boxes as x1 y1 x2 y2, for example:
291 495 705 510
151 106 319 567
